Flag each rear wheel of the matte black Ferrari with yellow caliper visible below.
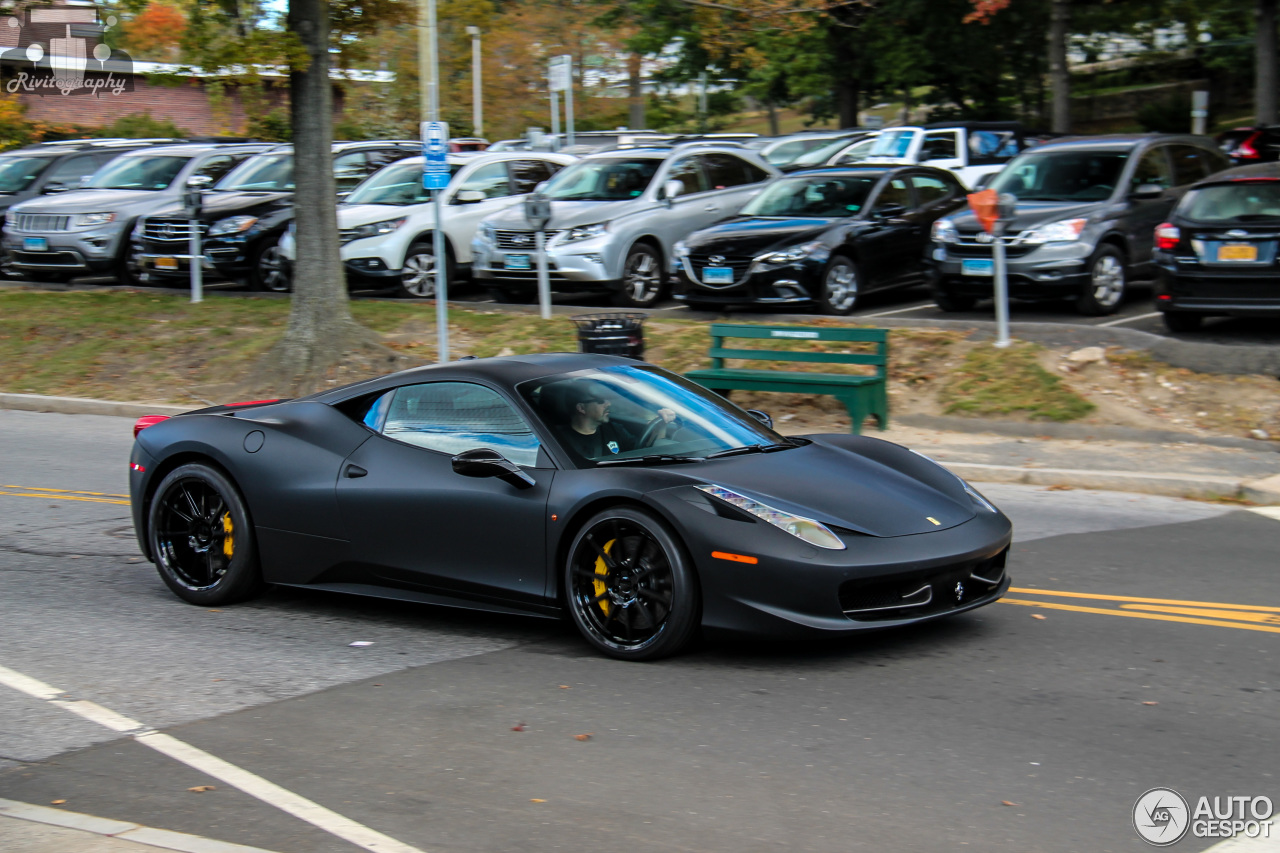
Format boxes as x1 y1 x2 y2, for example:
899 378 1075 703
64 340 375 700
147 462 262 606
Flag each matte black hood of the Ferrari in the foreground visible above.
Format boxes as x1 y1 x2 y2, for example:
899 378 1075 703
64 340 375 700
680 435 975 537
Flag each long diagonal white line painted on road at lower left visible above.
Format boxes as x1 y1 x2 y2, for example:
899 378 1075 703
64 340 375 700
0 666 422 853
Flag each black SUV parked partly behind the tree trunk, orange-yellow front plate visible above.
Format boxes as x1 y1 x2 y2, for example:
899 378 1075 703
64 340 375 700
133 140 422 286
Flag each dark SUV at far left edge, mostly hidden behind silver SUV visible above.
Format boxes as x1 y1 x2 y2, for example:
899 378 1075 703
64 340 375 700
0 140 184 280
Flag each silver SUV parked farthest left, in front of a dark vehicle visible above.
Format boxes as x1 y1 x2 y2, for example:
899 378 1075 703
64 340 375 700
4 143 270 284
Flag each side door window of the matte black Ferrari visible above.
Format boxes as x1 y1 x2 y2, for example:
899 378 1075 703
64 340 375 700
378 382 539 466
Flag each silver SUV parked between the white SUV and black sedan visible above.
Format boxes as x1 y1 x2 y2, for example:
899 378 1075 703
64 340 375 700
471 142 780 307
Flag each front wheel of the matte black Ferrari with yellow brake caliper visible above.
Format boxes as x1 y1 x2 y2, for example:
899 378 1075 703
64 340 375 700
564 506 701 661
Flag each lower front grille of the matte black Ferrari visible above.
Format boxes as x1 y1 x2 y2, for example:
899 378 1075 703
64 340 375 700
838 548 1009 622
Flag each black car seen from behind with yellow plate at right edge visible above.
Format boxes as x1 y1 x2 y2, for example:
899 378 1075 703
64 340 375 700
1155 163 1280 332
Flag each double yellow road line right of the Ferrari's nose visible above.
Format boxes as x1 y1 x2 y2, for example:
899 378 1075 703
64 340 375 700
1000 587 1280 634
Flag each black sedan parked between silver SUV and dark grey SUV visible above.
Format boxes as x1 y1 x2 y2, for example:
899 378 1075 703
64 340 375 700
671 165 965 314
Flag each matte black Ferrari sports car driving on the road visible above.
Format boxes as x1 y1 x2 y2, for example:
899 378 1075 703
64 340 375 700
129 353 1011 660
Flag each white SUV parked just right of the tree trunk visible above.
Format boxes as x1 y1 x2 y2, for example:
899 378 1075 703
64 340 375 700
280 151 577 298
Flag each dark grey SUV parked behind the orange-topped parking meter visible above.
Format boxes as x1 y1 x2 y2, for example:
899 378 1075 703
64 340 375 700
933 133 1230 315
